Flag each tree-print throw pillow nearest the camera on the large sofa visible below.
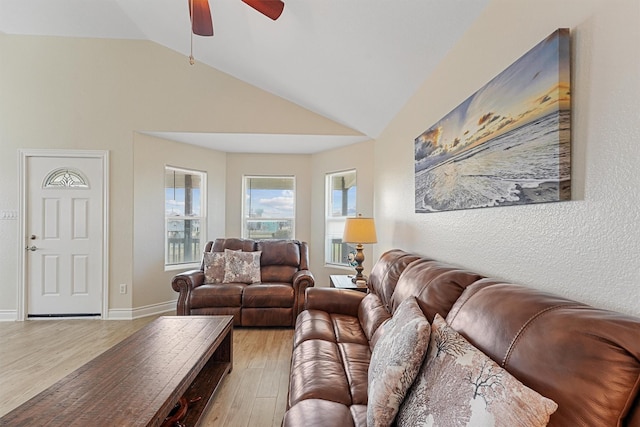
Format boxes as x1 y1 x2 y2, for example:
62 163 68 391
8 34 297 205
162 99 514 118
396 314 558 427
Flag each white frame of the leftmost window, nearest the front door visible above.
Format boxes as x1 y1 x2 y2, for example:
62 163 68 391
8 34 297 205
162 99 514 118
163 165 208 271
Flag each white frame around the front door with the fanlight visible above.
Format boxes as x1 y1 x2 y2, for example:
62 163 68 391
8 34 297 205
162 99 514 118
16 149 109 321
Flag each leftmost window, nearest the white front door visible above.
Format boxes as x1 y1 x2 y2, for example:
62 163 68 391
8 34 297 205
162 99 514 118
164 166 207 267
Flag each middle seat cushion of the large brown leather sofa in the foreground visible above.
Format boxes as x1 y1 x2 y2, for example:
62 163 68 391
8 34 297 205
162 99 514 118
288 340 351 407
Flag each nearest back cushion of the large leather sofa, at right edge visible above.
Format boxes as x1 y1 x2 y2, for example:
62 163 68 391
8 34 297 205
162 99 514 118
447 279 640 426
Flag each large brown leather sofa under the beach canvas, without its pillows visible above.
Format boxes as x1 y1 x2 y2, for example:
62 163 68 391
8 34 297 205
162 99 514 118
283 249 640 427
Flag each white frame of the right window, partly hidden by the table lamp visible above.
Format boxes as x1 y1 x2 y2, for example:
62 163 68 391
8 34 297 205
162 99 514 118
324 168 358 269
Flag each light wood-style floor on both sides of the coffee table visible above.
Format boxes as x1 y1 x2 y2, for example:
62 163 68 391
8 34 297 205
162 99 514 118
0 317 293 427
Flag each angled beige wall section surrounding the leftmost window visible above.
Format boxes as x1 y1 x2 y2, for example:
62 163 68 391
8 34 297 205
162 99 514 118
132 134 226 317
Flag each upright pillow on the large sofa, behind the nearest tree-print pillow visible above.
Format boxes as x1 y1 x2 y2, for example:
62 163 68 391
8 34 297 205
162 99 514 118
367 297 431 427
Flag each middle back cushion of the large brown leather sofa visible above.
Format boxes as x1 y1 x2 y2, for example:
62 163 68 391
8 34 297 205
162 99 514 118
391 259 482 322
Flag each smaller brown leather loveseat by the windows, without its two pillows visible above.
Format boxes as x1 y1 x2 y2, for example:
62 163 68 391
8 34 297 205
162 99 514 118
171 238 314 326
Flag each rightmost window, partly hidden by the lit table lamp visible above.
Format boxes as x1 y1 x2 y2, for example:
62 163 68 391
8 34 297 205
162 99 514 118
325 170 356 265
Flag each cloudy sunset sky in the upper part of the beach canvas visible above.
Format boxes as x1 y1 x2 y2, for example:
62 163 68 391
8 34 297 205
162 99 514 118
415 30 570 166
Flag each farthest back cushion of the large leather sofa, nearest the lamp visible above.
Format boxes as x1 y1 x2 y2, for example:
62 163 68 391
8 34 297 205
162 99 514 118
367 249 420 311
